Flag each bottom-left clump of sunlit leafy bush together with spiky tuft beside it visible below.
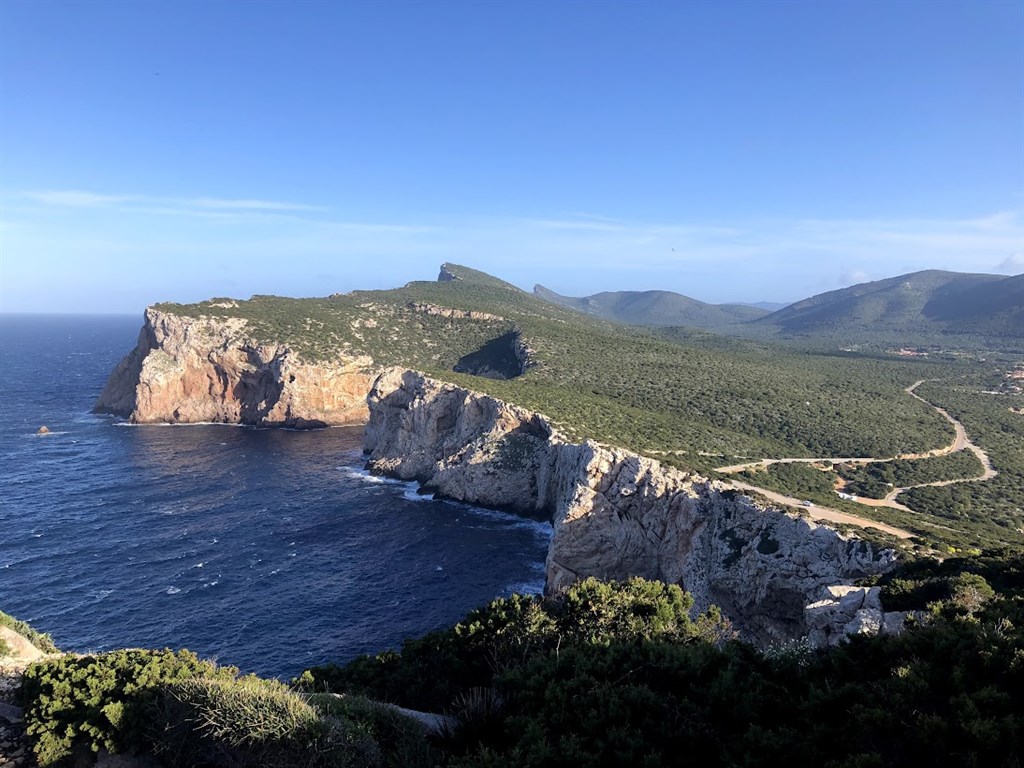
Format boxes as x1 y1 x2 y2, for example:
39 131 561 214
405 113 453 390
22 650 428 768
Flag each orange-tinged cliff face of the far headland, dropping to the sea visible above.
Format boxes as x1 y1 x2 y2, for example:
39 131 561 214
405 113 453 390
95 308 373 427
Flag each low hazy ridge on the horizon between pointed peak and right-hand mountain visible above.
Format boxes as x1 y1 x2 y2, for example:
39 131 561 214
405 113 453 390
534 285 768 330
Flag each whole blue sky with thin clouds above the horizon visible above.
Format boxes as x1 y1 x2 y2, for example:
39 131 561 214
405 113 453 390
0 0 1024 312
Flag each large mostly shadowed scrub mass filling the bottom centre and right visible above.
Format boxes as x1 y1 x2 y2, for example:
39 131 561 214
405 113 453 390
300 573 1024 768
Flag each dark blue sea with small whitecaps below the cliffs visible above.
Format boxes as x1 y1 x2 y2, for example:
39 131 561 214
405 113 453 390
0 315 550 677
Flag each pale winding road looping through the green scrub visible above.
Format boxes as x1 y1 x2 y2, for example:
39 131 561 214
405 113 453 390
715 379 998 539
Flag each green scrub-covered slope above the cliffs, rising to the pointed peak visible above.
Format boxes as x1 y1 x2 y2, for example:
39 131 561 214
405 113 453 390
155 264 1024 546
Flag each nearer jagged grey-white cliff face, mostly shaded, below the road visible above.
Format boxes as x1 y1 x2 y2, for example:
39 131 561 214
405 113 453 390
365 369 894 642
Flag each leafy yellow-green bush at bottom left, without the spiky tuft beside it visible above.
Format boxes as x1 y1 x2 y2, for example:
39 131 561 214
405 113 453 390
19 649 234 766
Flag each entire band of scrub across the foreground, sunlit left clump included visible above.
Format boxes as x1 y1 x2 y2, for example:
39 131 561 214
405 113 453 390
16 577 1024 768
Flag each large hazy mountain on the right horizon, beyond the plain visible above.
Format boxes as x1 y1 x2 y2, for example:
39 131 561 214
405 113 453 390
753 269 1024 337
